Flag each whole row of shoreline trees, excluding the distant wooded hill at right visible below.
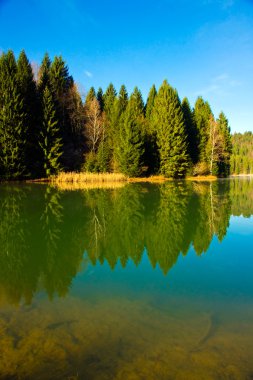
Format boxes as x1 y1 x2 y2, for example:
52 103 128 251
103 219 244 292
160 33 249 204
0 51 232 179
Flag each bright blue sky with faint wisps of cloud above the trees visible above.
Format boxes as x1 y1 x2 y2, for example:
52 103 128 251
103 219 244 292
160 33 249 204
0 0 253 132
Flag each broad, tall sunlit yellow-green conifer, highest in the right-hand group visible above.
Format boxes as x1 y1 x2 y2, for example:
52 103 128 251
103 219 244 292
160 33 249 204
152 81 189 178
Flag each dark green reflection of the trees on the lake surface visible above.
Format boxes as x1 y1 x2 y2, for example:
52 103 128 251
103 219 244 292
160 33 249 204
0 180 253 304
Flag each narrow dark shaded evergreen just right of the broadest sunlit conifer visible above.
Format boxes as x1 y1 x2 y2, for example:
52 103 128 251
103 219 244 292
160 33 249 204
182 98 198 164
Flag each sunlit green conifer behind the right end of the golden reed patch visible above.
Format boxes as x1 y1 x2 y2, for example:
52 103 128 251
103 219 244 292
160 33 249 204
117 87 144 176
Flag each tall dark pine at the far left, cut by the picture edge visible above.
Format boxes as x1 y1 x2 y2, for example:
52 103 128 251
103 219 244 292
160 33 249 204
0 51 27 179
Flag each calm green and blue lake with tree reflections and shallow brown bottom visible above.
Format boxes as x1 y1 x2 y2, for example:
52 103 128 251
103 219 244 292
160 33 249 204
0 179 253 380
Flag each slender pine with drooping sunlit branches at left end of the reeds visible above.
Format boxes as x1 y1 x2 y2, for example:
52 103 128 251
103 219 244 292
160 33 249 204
39 87 62 177
